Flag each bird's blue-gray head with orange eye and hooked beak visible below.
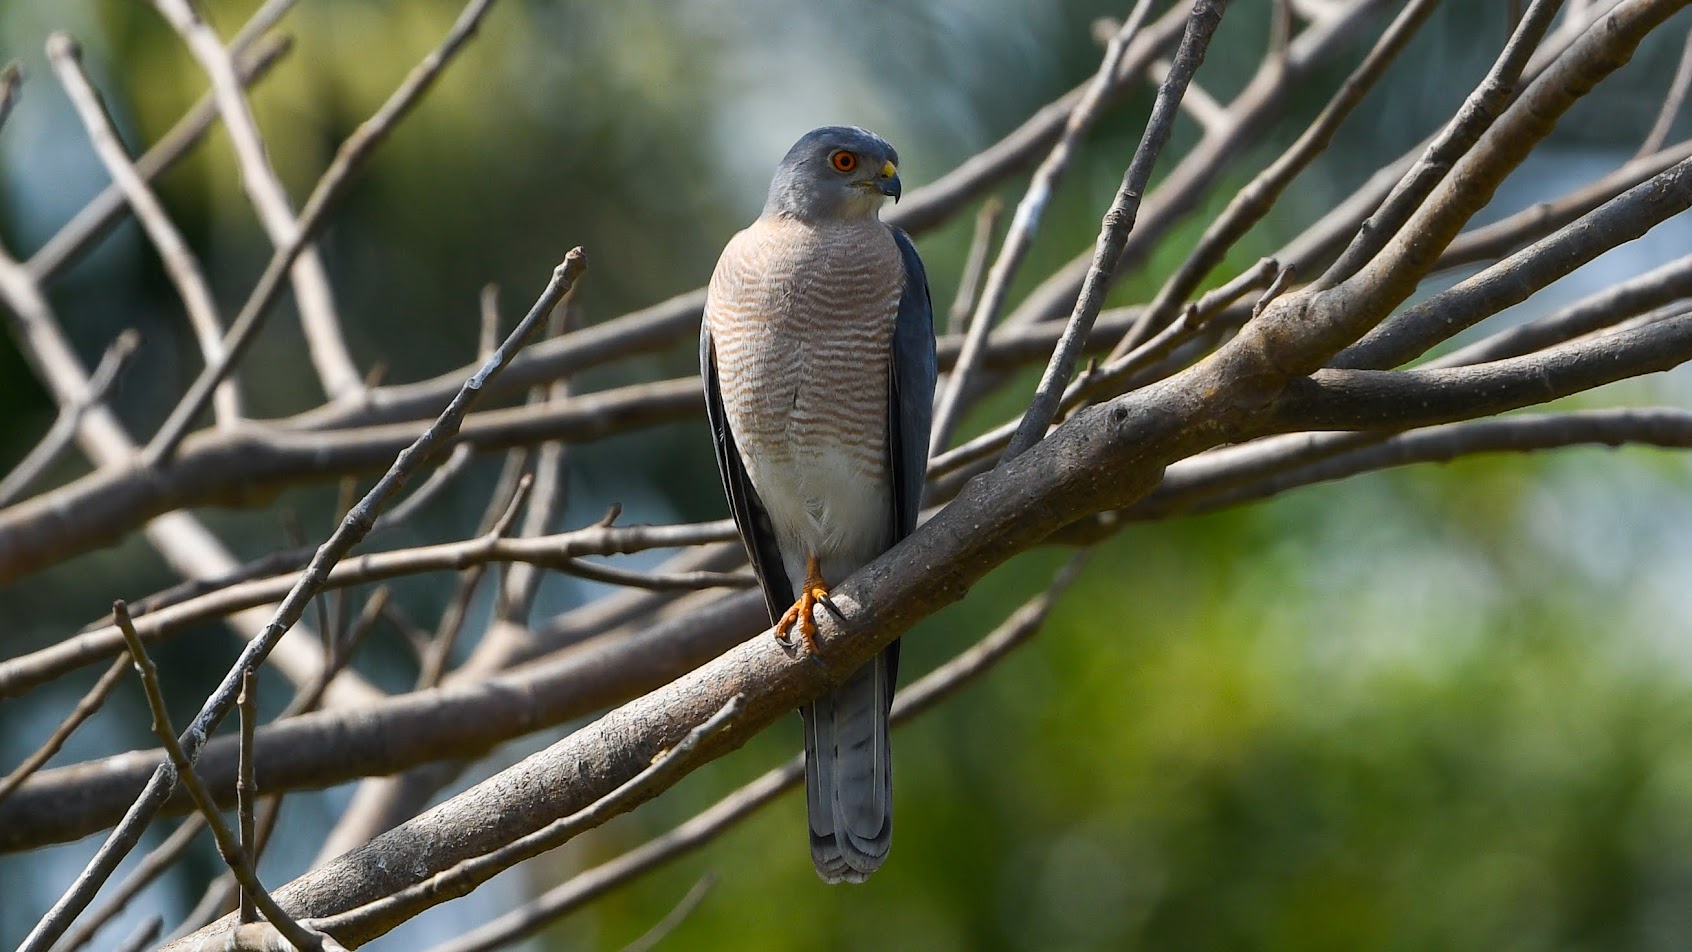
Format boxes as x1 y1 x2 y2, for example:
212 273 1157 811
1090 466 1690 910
763 125 900 222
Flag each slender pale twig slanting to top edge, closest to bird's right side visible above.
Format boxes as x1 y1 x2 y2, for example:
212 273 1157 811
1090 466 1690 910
929 0 1151 448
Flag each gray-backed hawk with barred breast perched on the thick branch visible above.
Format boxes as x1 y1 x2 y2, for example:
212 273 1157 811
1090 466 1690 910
699 125 936 883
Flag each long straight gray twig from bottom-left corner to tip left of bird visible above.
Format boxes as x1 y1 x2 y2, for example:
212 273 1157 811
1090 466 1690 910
20 249 587 952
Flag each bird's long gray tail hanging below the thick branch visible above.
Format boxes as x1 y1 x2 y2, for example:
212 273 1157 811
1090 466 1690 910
800 643 898 883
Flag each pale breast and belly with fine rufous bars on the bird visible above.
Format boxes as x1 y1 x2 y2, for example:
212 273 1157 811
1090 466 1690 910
706 220 904 573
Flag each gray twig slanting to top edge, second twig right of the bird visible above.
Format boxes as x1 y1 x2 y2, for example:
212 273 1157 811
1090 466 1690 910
1000 0 1227 463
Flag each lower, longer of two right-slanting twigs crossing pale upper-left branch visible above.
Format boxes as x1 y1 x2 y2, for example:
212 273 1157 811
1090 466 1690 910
144 0 492 467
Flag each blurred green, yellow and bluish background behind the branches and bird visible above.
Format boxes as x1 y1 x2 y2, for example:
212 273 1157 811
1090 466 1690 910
0 0 1692 950
